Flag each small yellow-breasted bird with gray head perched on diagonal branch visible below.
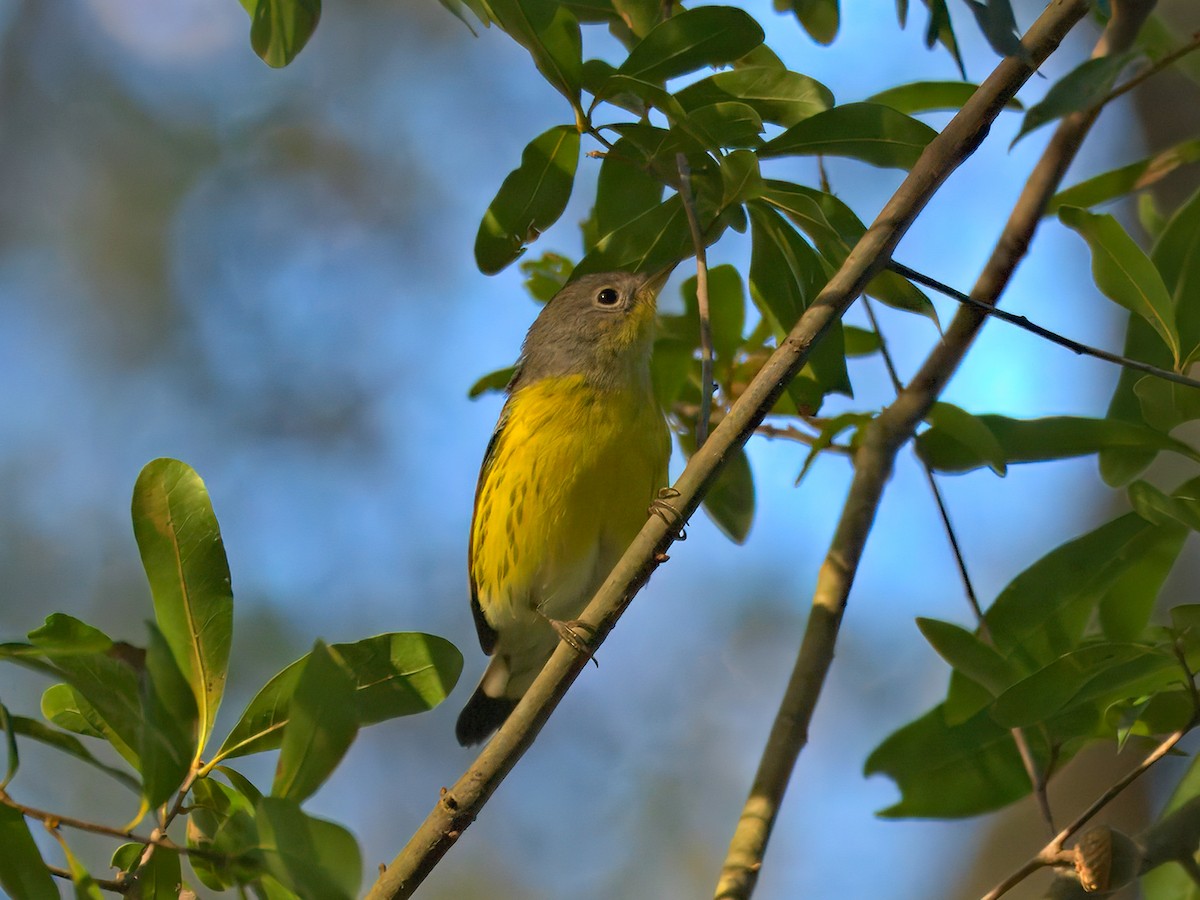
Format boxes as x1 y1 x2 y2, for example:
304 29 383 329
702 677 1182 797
455 269 671 746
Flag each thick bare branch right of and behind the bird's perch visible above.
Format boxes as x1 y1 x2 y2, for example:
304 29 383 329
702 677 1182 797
716 2 1096 900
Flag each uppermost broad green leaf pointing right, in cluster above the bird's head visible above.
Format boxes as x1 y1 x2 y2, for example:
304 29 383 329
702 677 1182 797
617 6 763 82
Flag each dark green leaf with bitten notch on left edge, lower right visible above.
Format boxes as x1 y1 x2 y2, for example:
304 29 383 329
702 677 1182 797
865 707 1045 818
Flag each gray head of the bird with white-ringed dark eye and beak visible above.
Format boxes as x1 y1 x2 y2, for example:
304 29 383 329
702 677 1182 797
512 271 670 390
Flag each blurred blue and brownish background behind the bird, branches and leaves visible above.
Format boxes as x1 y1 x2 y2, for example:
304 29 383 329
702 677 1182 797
0 0 1200 900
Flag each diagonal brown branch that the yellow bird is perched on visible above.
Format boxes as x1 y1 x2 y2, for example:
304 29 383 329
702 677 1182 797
367 0 1090 900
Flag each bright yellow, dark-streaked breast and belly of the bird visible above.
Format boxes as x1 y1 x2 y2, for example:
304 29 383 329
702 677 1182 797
470 376 671 628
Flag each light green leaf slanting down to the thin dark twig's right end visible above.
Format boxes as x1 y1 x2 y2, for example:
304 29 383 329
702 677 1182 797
1058 206 1180 367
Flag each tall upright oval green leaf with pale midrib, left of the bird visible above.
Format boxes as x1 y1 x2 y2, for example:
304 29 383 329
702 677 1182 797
132 460 233 758
